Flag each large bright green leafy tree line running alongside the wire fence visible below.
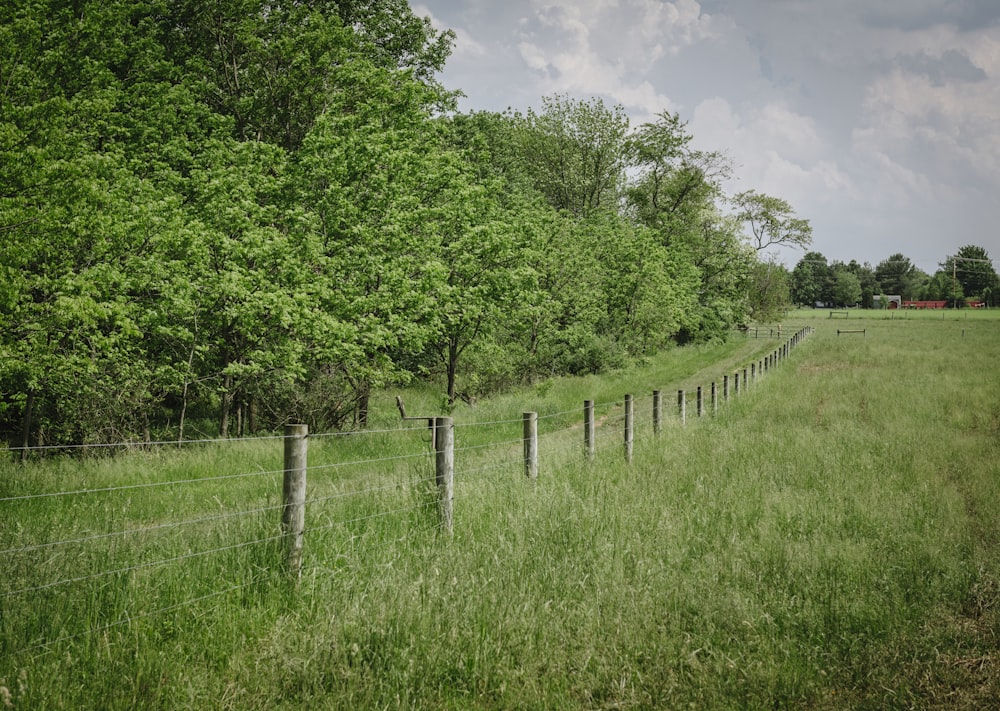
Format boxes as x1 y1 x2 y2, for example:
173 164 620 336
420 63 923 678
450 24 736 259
0 0 811 446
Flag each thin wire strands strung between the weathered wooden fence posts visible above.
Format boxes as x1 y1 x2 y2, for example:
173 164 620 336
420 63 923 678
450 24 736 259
0 332 805 654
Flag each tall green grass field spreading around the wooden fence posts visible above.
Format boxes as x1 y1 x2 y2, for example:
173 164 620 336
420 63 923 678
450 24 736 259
0 310 1000 709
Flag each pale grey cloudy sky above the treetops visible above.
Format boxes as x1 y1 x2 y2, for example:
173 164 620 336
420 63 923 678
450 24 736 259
411 0 1000 273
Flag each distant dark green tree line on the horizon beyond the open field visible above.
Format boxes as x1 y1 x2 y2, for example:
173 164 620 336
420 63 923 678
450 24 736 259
789 245 1000 309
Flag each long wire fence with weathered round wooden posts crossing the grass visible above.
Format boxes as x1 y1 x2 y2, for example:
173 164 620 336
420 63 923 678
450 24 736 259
0 329 810 655
